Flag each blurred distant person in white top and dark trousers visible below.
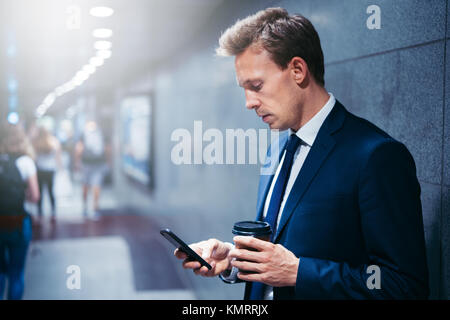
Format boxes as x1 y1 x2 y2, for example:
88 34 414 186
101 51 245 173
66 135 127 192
33 127 62 221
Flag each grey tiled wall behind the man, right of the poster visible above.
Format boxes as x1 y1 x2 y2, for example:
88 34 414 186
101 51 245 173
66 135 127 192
117 0 450 299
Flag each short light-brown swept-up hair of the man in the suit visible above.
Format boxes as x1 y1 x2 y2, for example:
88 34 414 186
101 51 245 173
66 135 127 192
216 8 325 86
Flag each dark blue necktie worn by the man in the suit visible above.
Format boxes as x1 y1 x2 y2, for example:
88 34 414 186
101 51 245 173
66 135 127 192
249 134 301 300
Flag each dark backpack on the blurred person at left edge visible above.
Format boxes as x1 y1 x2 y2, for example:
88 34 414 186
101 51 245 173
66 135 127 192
0 154 26 216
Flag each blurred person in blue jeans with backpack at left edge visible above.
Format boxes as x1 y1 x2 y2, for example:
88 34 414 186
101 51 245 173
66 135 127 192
0 123 40 300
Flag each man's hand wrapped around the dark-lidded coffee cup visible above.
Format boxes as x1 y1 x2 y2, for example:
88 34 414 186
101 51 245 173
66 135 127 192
229 236 299 287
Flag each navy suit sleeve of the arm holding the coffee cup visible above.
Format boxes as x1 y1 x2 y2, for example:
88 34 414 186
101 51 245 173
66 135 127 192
295 140 429 299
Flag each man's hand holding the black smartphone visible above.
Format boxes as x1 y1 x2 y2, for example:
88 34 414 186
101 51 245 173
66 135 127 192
174 239 233 277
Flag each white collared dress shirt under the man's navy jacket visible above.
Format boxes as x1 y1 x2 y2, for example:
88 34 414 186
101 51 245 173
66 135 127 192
263 93 336 300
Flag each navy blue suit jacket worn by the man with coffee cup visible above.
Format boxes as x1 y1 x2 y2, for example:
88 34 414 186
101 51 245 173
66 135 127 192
246 101 429 299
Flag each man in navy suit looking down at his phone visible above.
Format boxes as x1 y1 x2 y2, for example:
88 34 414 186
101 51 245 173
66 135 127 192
175 8 429 299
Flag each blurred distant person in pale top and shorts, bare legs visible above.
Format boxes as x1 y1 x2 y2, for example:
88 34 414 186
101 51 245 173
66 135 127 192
75 121 110 219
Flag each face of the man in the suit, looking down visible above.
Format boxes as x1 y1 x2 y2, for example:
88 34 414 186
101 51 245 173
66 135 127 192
235 47 302 130
